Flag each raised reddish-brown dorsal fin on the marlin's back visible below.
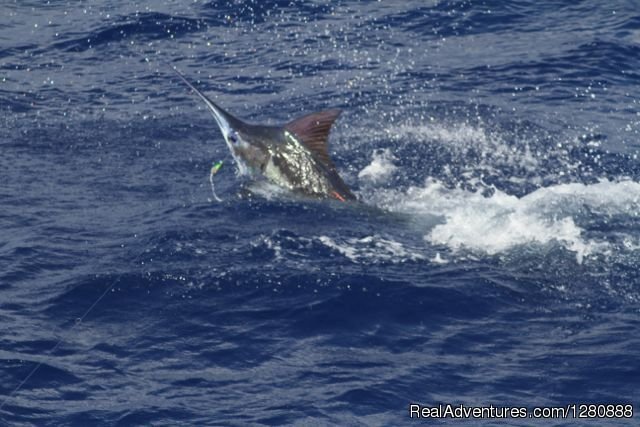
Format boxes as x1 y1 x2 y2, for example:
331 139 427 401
284 110 340 168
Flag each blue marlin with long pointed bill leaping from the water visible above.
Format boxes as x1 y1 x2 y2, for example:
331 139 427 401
174 68 356 202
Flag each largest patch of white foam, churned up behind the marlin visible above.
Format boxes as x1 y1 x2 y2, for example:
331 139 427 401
373 180 640 262
